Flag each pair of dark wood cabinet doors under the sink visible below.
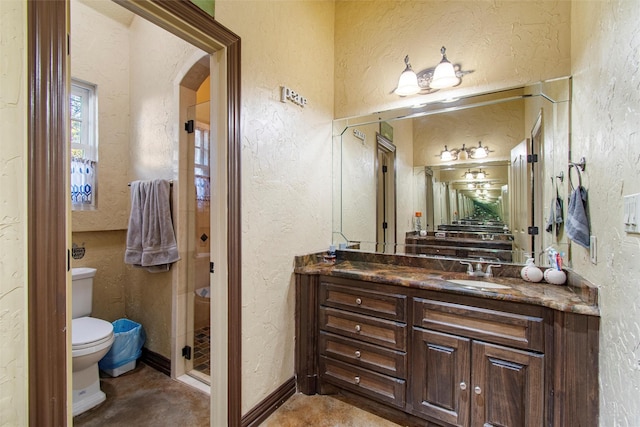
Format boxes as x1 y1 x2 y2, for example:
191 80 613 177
410 328 544 427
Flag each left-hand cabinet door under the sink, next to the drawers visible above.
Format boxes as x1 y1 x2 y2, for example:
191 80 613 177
409 328 471 426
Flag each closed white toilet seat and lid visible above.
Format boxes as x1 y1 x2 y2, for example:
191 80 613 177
71 317 113 357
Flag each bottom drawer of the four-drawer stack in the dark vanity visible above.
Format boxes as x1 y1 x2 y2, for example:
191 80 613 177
320 356 406 408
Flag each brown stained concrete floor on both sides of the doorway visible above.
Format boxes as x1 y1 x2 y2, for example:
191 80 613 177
73 362 398 427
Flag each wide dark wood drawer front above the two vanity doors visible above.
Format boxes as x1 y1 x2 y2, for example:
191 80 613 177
413 298 544 352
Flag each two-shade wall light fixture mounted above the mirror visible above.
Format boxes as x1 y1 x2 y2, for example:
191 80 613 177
393 46 473 96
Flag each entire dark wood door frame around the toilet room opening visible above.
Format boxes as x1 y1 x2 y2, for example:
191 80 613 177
27 0 242 426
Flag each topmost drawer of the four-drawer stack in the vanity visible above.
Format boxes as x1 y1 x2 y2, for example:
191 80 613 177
319 278 407 322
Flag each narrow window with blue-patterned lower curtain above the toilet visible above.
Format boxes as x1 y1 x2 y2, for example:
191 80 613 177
70 79 98 210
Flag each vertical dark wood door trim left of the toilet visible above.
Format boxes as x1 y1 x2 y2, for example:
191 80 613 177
25 0 70 426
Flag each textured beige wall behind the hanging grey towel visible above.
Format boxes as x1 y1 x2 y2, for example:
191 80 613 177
123 17 206 358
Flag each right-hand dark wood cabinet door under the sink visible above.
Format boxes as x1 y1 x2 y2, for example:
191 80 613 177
471 341 544 427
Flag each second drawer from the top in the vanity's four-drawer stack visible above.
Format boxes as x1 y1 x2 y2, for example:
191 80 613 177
319 307 407 351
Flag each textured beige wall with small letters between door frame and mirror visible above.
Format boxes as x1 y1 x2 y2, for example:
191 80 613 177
216 0 334 413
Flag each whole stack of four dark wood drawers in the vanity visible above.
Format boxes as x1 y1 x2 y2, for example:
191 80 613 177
318 278 407 408
